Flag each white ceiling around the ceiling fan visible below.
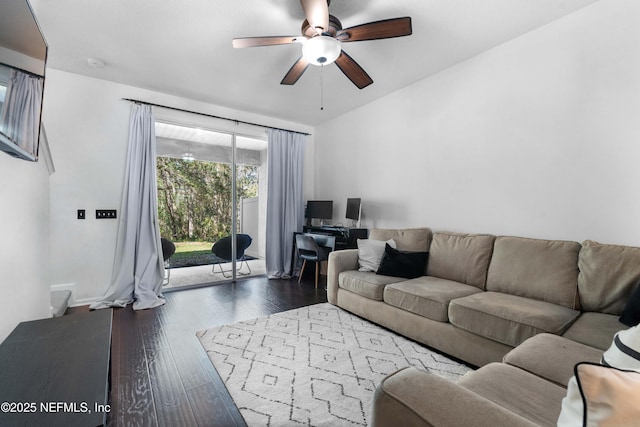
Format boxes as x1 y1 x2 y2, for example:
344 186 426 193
30 0 597 125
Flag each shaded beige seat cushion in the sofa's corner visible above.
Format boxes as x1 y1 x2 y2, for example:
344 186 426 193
562 312 629 350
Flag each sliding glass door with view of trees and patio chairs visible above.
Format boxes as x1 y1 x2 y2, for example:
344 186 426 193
156 122 267 288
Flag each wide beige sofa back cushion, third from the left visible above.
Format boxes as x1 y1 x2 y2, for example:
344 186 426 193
486 236 580 309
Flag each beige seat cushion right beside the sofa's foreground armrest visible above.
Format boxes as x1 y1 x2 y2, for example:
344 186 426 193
458 363 567 426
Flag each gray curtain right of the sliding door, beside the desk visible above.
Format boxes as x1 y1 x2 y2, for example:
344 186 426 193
265 129 306 279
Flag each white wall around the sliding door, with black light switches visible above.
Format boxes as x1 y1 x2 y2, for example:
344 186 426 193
43 70 313 304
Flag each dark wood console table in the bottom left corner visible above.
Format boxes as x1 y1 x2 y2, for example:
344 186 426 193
0 309 113 426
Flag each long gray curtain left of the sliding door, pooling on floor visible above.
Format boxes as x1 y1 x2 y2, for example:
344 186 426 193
91 104 164 310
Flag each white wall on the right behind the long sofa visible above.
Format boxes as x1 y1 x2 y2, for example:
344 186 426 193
316 0 640 246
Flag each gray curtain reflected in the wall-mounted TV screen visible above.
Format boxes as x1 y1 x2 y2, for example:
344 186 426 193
0 69 42 155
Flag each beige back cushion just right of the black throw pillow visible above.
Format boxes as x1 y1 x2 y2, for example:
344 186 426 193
427 232 495 289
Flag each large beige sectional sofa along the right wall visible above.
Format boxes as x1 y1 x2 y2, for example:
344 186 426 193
327 228 640 426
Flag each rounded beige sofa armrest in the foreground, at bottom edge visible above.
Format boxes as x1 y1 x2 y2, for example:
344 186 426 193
372 367 535 427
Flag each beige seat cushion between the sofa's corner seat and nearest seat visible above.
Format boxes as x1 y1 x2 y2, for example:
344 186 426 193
504 334 602 388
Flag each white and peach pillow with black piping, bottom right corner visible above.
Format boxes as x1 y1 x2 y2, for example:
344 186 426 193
557 362 640 427
